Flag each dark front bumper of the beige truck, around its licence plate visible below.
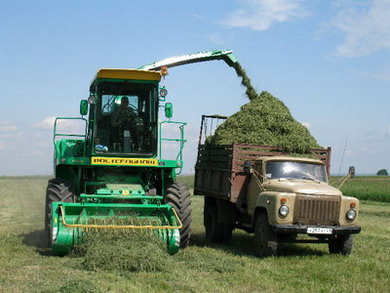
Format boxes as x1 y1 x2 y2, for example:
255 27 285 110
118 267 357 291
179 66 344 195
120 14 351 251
272 225 362 235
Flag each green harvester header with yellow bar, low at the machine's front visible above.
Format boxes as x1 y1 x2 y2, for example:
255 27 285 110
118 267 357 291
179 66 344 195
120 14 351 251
52 202 182 254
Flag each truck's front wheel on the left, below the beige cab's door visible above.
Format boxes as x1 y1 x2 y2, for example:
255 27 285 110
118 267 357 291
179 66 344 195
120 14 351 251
254 214 278 257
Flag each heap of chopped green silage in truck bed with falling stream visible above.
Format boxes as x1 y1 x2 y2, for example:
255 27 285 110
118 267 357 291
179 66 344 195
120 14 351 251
207 63 320 153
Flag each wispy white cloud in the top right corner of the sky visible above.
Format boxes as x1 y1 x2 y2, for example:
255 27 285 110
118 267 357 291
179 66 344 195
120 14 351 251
329 0 390 57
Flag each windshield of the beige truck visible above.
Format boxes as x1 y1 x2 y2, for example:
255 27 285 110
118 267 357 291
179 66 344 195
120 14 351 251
266 161 327 182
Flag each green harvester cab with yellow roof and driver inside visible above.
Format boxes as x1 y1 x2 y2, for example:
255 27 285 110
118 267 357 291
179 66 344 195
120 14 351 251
88 69 161 157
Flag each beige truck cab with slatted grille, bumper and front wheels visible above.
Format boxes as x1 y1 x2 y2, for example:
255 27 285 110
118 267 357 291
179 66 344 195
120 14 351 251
247 157 360 254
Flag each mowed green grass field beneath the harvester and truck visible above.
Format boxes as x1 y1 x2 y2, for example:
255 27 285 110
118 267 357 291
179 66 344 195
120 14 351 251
0 177 390 292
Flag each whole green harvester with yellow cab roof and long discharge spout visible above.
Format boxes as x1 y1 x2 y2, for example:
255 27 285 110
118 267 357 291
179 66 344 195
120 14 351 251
45 51 237 254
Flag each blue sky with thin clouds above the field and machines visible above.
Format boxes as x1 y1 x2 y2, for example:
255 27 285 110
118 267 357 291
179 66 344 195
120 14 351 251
0 0 390 175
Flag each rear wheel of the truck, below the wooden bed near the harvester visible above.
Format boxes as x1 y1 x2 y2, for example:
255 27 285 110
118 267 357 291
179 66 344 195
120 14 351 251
204 205 233 243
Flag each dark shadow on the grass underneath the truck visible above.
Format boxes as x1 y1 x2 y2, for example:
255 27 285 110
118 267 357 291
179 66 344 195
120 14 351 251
190 232 326 257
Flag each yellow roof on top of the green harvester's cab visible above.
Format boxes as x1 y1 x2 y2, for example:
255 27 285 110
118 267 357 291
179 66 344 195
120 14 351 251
91 68 161 85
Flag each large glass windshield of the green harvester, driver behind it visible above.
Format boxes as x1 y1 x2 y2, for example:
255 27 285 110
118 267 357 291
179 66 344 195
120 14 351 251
94 81 157 156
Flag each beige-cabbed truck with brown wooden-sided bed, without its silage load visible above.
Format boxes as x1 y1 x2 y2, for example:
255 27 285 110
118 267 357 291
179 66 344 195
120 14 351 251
194 115 361 257
